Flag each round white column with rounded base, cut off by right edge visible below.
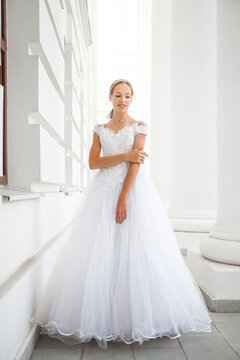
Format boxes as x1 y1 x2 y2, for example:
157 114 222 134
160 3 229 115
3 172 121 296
200 0 240 265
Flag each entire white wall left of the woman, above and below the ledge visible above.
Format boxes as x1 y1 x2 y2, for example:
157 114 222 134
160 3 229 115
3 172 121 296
0 0 93 360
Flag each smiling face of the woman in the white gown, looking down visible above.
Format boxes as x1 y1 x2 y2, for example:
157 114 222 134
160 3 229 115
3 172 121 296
109 83 132 113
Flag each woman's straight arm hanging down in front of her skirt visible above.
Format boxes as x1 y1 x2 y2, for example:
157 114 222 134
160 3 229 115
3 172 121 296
115 123 146 224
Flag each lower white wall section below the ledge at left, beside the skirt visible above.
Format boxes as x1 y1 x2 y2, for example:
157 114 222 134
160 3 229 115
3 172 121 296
0 193 80 359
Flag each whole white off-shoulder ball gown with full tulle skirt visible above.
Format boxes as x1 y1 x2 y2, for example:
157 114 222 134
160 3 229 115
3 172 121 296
31 122 212 349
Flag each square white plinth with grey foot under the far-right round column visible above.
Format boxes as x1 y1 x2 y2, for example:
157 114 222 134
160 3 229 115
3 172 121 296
186 249 240 312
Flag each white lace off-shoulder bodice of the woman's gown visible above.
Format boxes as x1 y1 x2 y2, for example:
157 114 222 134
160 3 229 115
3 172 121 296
93 121 148 191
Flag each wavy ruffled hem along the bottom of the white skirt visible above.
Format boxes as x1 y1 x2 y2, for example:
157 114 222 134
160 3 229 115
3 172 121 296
31 318 212 349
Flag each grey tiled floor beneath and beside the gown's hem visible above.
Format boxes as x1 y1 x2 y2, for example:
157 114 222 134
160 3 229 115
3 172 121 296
31 312 240 360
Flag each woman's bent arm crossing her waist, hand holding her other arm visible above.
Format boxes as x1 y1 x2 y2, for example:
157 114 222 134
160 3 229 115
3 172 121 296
89 133 148 170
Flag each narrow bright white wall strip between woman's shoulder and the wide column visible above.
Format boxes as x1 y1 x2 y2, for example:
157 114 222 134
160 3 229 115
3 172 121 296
151 0 172 207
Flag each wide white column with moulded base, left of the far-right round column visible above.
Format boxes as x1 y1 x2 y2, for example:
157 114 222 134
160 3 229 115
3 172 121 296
169 0 216 233
